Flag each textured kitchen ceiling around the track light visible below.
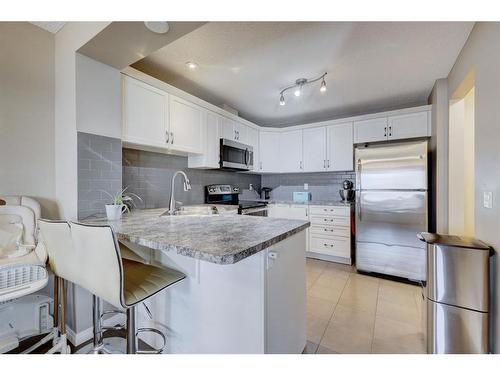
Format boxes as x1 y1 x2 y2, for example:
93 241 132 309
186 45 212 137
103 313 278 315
133 22 473 126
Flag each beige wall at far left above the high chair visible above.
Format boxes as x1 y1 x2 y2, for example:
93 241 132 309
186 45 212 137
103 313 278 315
0 22 58 218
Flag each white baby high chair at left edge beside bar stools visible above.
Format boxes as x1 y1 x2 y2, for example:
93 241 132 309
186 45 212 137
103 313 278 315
0 196 69 353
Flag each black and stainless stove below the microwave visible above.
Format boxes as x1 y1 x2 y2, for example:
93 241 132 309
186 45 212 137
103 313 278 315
205 185 267 216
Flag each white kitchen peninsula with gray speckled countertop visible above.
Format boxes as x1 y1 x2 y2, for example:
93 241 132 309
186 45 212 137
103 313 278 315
86 209 310 353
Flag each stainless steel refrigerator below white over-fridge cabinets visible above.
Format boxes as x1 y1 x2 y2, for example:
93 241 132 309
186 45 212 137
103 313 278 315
355 141 428 281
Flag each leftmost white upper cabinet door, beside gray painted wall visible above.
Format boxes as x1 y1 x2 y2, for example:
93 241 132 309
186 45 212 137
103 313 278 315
123 76 168 148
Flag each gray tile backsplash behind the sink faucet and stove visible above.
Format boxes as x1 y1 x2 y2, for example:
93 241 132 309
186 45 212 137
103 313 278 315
123 148 261 208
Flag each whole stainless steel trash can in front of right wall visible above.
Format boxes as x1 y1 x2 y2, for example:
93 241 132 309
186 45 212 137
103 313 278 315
418 233 493 354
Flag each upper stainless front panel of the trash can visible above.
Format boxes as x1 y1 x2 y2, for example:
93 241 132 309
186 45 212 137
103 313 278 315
427 244 490 312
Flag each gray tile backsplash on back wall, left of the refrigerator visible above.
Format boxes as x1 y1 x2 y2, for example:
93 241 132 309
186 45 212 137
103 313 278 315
261 172 356 200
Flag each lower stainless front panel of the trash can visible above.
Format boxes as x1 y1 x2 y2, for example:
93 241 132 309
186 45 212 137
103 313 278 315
426 299 488 354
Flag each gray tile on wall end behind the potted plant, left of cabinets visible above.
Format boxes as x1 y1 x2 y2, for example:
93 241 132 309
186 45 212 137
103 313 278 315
77 132 122 219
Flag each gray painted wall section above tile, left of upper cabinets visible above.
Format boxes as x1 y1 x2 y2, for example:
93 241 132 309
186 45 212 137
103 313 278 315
76 53 122 138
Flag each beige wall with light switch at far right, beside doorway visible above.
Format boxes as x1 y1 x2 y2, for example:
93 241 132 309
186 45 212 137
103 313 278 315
448 22 500 352
